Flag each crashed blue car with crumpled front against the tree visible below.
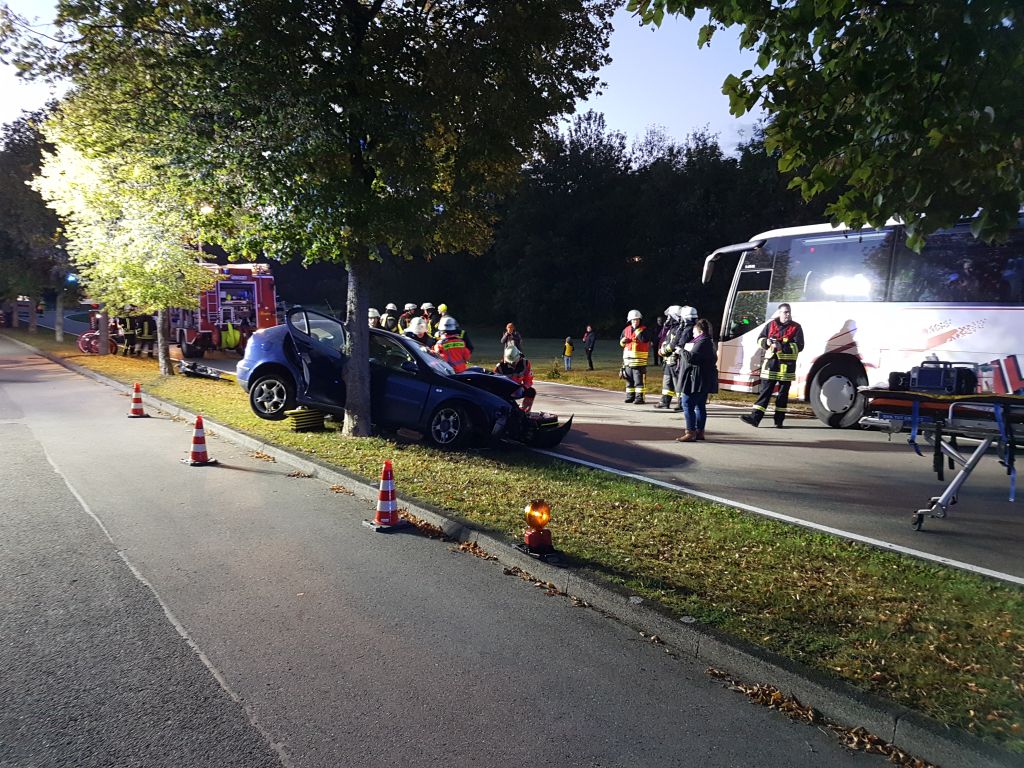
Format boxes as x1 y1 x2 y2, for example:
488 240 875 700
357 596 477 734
237 307 572 447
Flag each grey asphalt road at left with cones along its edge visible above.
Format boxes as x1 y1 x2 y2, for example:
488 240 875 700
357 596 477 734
0 338 886 768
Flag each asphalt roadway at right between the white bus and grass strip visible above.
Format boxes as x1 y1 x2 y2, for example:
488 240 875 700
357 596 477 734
537 382 1024 578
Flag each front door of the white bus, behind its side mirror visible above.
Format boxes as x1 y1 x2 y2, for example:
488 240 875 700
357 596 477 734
718 248 773 391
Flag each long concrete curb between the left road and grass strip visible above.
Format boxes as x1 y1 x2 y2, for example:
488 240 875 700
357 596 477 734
5 336 1024 768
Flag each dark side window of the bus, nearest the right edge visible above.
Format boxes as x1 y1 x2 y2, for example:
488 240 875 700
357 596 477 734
891 224 1024 304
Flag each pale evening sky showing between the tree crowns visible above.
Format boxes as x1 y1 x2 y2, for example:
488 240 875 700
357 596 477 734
0 0 756 152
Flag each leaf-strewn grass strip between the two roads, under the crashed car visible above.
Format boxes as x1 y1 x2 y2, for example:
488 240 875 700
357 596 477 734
7 331 1024 753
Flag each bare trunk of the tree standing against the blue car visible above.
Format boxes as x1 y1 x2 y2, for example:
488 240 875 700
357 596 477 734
342 259 370 437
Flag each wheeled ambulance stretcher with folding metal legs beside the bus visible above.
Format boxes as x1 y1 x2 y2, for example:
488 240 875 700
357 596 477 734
860 387 1024 530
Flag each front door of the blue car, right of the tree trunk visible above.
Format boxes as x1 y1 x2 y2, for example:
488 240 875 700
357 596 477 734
370 332 430 429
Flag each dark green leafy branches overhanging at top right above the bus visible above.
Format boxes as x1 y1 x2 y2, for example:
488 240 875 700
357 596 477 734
629 0 1024 246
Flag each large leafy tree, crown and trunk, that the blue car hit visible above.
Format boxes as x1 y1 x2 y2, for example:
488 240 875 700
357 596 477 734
4 0 616 434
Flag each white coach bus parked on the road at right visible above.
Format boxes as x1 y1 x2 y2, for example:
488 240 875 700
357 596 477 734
703 221 1024 427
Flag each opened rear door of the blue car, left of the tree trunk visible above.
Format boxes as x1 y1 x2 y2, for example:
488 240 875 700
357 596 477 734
286 307 346 408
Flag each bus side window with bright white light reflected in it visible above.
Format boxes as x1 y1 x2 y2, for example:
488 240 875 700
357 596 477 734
771 229 893 302
